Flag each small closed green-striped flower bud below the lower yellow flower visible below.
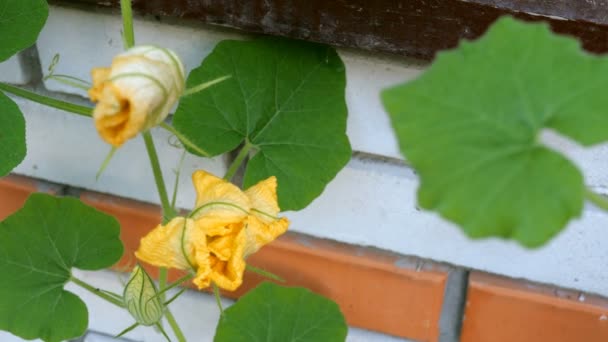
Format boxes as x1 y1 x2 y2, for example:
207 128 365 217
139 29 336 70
123 265 164 325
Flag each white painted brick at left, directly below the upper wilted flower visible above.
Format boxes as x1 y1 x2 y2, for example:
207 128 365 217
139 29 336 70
10 99 226 208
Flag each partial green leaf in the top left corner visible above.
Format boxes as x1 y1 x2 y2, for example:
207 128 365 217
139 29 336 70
0 0 49 62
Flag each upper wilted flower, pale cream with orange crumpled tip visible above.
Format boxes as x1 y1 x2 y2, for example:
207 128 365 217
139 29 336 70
89 46 185 147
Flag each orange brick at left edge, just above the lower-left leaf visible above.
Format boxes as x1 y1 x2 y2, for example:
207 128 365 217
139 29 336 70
0 175 59 220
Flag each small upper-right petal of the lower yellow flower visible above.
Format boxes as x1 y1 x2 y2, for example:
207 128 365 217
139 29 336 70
245 176 281 222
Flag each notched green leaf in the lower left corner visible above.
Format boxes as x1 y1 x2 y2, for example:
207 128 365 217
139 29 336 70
0 194 123 341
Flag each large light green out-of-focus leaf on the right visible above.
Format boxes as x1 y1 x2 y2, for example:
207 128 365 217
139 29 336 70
382 18 608 247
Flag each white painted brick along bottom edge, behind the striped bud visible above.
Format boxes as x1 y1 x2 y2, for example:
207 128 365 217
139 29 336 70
0 271 406 342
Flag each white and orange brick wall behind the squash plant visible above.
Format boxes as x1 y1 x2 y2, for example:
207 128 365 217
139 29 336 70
0 3 608 342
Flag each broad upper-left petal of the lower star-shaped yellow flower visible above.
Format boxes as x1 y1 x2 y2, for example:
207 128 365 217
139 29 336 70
192 171 250 236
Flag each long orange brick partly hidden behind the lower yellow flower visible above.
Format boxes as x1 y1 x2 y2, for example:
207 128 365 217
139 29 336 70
81 192 447 341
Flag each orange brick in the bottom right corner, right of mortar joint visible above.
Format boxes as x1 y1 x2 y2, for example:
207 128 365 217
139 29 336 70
461 273 608 342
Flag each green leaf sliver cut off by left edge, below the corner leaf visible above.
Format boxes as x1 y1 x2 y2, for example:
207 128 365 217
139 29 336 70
0 92 26 177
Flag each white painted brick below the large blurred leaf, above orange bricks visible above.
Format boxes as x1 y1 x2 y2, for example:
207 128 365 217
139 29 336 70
288 156 608 296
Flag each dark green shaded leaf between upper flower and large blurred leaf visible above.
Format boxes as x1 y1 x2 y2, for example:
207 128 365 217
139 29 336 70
173 39 351 210
